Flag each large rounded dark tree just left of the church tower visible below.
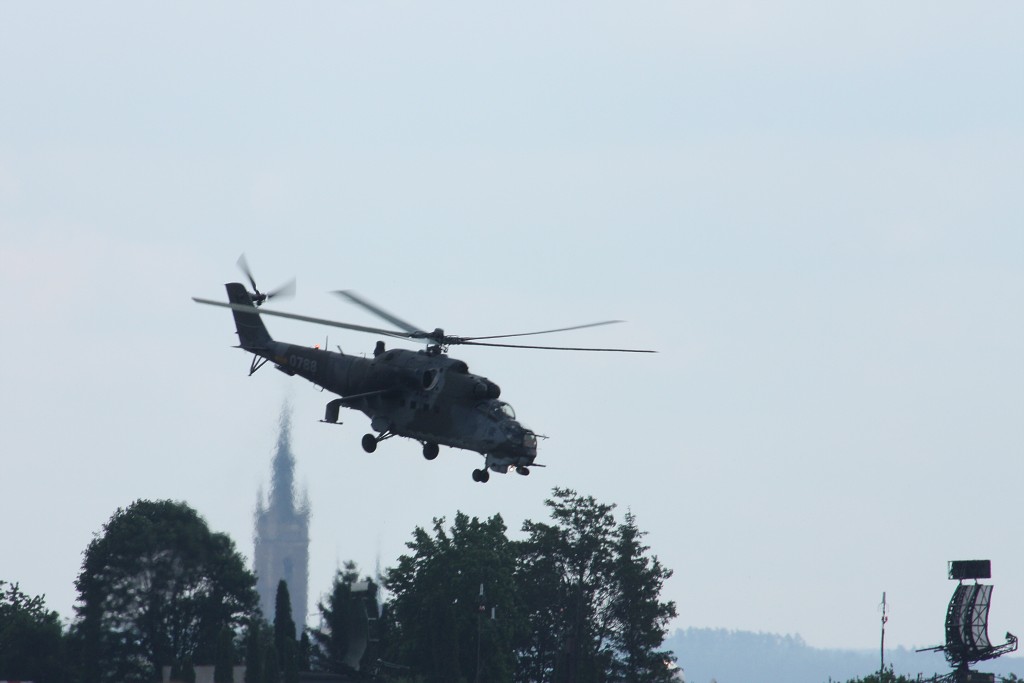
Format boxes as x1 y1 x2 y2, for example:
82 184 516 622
76 501 257 683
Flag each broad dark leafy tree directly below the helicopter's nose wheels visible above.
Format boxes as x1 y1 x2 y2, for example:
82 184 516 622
384 512 522 683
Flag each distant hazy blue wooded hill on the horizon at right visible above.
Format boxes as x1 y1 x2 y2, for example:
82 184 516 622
665 629 1024 683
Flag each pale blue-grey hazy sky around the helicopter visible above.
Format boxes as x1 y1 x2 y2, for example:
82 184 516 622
0 0 1024 655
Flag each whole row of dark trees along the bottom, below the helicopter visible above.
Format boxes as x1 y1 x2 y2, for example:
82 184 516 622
0 488 676 683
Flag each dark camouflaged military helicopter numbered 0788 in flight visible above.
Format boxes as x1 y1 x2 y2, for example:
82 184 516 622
193 264 654 483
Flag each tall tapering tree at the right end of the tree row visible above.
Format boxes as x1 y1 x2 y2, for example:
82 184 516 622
610 512 676 683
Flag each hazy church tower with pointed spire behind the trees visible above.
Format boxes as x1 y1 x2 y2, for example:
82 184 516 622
253 407 309 634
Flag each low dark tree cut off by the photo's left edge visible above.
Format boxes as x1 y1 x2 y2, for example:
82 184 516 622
0 581 69 681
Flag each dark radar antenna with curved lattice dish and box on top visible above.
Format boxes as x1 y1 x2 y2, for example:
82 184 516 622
918 560 1017 683
